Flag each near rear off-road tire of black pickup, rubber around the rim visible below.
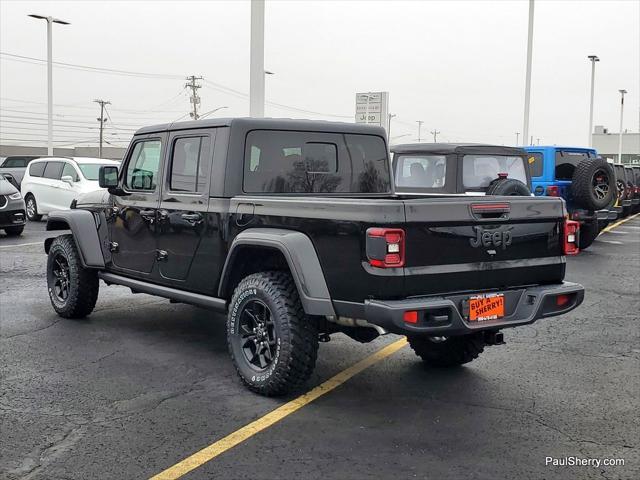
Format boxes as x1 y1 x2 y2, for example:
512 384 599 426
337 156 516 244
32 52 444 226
227 271 318 396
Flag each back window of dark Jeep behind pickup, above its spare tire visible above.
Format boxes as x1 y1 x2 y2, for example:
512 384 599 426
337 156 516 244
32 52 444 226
462 155 527 191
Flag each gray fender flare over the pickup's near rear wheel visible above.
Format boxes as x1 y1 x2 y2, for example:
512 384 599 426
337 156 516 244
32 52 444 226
218 228 335 316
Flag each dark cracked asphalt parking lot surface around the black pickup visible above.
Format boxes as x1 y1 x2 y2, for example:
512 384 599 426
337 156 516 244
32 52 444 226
0 216 640 479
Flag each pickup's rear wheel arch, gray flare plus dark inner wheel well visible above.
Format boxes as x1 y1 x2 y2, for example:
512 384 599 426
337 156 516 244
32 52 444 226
218 228 335 316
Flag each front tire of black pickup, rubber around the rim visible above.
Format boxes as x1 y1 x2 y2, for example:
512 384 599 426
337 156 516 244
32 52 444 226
47 235 100 318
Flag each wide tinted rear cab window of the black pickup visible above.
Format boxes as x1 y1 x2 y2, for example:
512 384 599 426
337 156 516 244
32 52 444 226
243 130 391 193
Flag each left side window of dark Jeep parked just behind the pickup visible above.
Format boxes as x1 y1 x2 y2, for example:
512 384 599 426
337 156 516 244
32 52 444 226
395 155 447 189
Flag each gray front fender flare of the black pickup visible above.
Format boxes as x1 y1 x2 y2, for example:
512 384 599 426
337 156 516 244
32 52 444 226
44 210 104 268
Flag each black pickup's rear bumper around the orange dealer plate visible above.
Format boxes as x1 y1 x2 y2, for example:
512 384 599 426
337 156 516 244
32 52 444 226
364 282 584 336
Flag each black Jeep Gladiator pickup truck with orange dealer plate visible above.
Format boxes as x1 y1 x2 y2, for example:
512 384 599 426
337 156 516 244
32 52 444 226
45 119 584 395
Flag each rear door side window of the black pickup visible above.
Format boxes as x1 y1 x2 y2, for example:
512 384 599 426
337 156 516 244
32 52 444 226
169 137 211 192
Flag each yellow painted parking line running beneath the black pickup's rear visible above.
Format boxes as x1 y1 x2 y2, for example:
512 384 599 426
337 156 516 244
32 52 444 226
151 338 407 480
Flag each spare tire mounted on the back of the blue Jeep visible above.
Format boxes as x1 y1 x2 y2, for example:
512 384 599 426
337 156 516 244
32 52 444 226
571 158 616 210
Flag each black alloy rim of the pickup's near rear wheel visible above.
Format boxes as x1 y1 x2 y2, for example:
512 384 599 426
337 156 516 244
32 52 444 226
239 299 278 372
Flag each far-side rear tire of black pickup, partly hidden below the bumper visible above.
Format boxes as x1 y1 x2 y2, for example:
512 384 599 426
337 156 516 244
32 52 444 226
408 334 485 367
